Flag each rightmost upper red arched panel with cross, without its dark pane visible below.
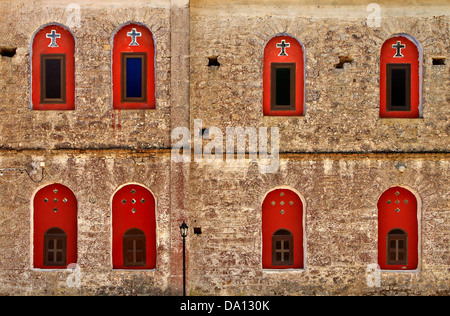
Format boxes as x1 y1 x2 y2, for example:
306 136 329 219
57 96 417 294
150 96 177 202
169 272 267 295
380 35 422 118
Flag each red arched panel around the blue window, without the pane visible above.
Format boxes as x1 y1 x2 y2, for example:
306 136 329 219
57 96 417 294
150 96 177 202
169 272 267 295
112 23 156 109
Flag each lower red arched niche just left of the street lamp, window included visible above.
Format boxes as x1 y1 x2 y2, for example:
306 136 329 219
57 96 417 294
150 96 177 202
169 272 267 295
112 184 156 269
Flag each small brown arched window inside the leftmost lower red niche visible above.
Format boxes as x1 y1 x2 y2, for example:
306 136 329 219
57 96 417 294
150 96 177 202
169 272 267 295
44 227 67 267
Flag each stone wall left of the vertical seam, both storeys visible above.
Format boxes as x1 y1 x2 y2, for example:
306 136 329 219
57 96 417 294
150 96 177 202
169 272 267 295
0 0 181 295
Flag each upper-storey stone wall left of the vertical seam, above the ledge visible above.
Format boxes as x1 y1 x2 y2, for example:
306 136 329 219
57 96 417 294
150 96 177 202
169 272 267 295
0 0 171 150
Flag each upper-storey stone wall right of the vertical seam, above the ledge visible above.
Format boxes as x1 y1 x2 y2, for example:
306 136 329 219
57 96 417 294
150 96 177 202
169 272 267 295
191 1 450 152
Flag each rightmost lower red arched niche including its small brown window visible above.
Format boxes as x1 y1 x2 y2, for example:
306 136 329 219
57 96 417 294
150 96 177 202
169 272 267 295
378 186 419 270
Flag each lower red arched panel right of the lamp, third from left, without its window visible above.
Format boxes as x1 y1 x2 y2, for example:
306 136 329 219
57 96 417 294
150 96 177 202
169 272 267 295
262 189 304 269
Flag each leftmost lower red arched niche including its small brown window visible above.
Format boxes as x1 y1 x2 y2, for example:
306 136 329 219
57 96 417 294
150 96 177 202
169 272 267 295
33 183 77 269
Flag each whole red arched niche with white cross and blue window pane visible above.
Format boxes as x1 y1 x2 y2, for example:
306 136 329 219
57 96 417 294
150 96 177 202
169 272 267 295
112 23 156 109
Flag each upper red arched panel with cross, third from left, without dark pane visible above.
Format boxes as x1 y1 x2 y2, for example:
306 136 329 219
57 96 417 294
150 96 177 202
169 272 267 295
263 35 305 116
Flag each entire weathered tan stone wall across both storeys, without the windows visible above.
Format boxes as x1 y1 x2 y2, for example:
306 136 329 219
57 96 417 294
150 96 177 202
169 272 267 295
0 0 450 295
